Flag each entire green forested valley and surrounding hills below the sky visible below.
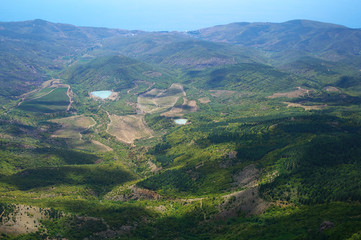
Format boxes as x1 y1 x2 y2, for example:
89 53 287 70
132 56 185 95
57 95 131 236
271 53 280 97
0 21 361 239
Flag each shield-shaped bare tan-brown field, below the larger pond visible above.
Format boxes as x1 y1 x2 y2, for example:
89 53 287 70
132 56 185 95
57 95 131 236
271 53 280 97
107 115 153 144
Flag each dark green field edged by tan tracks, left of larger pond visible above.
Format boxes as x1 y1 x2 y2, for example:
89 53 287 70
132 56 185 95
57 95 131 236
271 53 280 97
19 87 70 113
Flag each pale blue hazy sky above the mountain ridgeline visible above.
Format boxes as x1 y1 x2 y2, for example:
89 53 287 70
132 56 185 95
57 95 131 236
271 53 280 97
0 0 361 31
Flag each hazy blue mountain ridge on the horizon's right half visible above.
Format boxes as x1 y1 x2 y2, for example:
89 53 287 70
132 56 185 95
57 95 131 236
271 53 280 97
189 20 361 60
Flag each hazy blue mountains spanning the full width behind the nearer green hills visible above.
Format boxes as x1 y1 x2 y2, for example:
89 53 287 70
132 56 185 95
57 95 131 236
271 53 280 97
0 19 361 100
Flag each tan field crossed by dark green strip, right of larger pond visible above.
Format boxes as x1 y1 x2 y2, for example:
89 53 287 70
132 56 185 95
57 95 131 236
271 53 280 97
138 83 186 113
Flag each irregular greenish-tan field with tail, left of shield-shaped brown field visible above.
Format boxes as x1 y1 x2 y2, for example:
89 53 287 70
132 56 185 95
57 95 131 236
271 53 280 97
50 116 111 152
